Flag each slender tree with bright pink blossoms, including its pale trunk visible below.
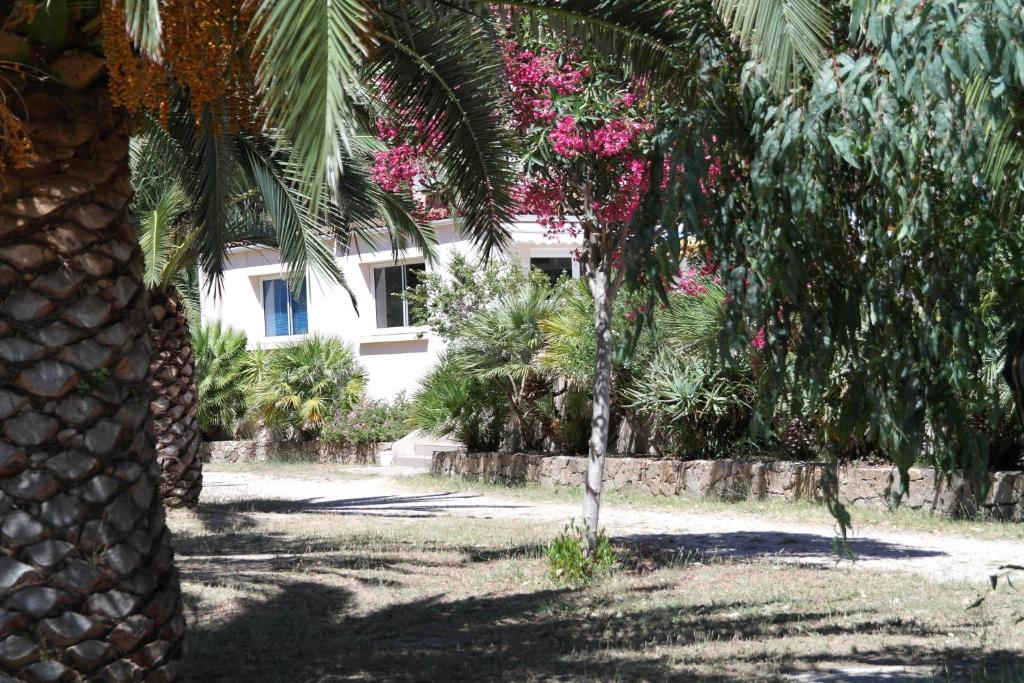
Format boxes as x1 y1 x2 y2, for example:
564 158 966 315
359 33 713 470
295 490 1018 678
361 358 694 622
372 22 718 551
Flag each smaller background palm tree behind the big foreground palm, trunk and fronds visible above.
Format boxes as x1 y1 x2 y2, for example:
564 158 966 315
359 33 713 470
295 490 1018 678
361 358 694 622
130 108 433 507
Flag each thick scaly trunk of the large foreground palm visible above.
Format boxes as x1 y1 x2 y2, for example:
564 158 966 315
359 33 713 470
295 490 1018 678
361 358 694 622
0 80 185 682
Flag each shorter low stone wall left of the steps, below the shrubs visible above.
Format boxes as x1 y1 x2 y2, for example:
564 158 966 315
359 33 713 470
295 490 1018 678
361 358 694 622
200 440 388 465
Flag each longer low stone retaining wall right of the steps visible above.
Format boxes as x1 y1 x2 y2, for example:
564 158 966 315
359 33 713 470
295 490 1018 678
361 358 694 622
431 453 1024 521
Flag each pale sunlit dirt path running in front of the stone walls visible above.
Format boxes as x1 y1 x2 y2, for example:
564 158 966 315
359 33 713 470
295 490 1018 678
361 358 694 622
203 468 1024 584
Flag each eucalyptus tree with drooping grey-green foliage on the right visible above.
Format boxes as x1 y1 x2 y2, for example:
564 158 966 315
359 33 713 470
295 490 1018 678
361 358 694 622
688 0 1024 528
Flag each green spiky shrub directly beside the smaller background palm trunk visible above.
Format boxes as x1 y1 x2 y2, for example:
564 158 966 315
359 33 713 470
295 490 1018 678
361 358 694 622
191 322 249 439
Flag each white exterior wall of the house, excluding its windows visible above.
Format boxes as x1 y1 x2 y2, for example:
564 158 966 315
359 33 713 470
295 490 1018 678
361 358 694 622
203 217 579 398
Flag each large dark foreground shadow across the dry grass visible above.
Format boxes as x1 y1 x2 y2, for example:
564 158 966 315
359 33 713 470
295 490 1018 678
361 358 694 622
182 548 1024 683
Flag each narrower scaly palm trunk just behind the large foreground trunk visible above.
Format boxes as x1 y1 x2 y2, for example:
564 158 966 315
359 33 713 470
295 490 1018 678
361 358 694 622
150 290 203 508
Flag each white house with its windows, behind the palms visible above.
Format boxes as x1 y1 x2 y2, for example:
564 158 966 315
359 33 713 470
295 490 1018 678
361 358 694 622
203 216 580 398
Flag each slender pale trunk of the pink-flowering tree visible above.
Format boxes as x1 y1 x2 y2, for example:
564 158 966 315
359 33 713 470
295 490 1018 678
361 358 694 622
583 268 614 556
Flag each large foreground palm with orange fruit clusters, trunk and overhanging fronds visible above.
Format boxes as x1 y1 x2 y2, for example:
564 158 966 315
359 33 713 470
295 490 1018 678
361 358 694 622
0 0 823 681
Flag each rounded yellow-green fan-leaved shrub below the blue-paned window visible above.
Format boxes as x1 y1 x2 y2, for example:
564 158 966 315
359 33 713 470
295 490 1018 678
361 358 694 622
251 335 367 438
